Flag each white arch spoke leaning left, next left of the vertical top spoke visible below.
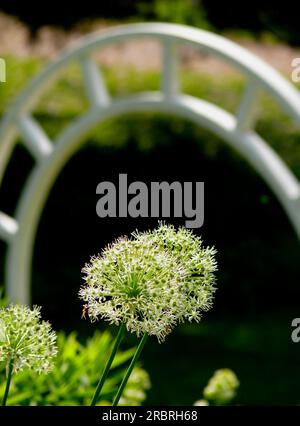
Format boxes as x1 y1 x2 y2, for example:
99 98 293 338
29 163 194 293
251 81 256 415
80 56 110 107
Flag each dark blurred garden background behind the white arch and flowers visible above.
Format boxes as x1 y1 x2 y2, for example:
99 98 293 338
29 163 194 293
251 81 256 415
0 0 300 405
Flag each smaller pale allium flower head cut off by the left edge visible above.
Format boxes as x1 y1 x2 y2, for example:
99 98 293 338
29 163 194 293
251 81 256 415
0 305 57 373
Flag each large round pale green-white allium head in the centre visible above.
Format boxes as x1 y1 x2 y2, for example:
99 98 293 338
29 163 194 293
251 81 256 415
79 224 216 342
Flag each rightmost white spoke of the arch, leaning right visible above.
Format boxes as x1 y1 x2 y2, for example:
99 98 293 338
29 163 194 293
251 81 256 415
236 79 259 131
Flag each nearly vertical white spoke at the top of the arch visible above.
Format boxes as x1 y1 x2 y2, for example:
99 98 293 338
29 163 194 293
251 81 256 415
161 39 179 97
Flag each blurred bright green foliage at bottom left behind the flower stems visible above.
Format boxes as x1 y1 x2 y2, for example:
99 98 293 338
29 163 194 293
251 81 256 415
0 332 150 405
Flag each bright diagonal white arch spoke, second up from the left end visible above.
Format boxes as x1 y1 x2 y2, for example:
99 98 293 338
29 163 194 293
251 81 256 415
18 115 53 161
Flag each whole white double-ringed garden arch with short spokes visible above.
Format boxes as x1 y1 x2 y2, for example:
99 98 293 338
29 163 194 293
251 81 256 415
0 23 300 303
